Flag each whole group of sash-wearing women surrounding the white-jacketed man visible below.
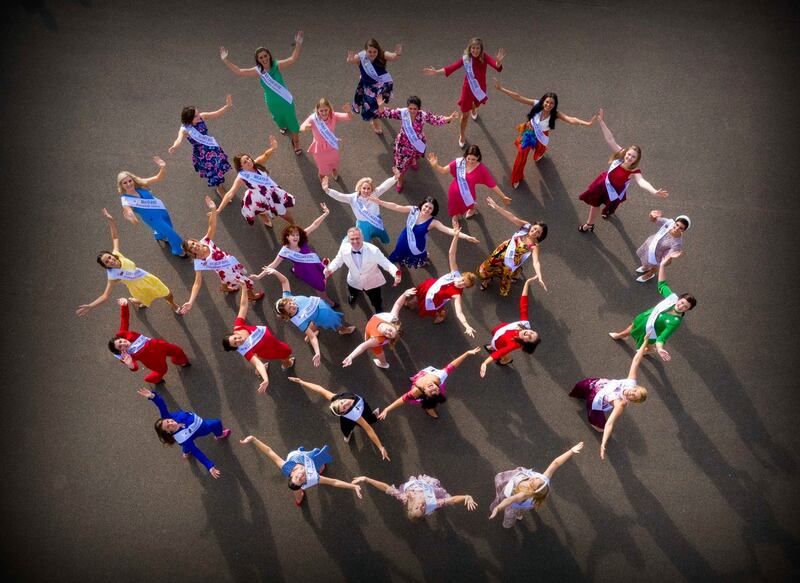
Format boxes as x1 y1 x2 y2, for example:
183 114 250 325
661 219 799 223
77 32 697 528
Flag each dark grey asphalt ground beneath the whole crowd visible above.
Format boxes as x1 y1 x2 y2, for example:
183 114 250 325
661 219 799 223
0 0 800 581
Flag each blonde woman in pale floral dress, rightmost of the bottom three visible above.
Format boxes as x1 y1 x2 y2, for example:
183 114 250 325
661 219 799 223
489 441 583 528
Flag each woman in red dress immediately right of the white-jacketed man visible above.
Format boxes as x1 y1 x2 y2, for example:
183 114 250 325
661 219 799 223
406 224 475 338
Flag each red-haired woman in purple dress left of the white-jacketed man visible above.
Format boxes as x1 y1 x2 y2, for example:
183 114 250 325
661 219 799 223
267 202 339 308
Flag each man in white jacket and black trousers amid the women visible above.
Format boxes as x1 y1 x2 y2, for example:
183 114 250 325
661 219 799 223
325 227 401 313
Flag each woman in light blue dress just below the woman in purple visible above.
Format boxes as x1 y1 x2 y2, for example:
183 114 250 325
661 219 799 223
258 267 356 366
